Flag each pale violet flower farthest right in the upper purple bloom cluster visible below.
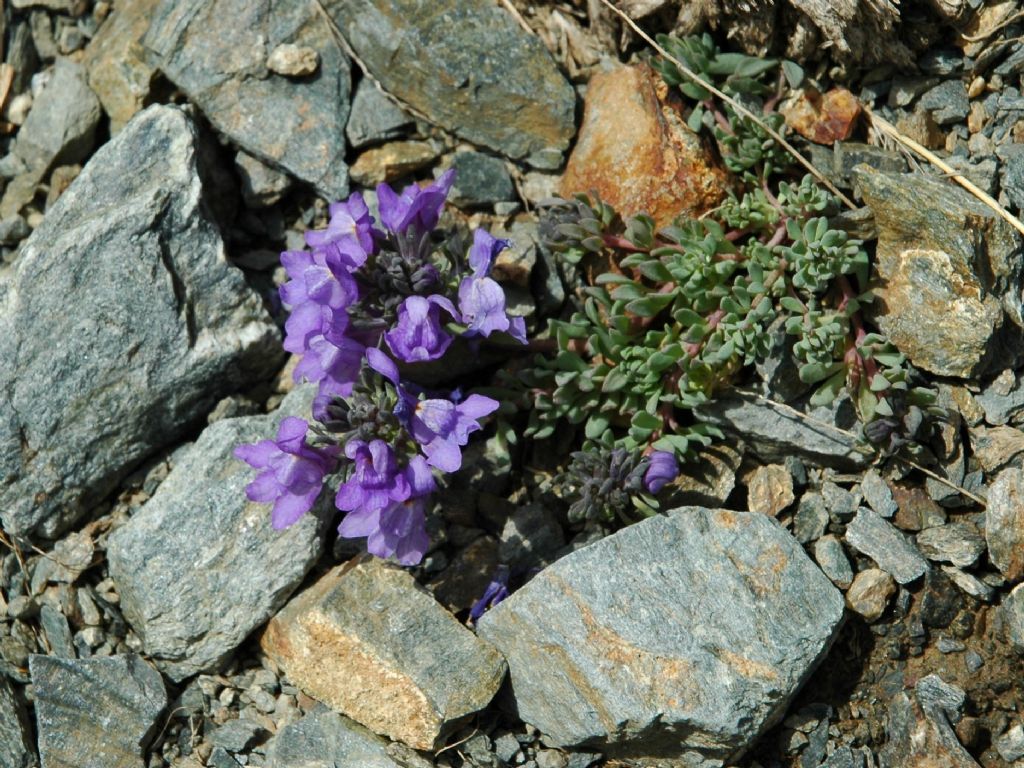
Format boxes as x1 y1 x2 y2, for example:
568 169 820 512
459 229 526 344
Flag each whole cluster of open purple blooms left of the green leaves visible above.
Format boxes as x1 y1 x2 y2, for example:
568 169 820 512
236 171 526 565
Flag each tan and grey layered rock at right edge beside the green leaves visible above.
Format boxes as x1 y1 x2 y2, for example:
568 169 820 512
855 166 1024 378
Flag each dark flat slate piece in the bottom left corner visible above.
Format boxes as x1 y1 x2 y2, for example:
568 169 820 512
29 653 167 768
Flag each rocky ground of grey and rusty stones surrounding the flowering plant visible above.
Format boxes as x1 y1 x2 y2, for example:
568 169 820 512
0 0 1024 768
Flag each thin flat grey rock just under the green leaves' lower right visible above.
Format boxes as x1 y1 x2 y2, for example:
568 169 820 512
694 394 868 469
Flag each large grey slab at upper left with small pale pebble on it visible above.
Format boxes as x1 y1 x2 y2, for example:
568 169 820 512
143 0 350 200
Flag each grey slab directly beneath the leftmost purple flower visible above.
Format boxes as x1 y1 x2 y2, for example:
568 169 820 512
106 386 329 681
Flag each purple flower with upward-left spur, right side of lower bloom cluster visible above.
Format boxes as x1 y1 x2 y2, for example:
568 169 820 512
367 348 500 472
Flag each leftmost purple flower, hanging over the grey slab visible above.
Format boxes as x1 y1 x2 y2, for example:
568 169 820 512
234 416 338 529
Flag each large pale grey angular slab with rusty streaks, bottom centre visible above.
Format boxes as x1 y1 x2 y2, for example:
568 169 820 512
479 507 843 761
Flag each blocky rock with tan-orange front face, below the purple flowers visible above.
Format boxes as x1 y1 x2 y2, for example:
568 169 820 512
260 559 505 750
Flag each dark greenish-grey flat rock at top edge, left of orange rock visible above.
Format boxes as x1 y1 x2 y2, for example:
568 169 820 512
324 0 575 162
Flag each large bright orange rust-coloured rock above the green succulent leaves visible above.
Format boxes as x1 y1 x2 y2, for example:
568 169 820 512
560 65 728 226
